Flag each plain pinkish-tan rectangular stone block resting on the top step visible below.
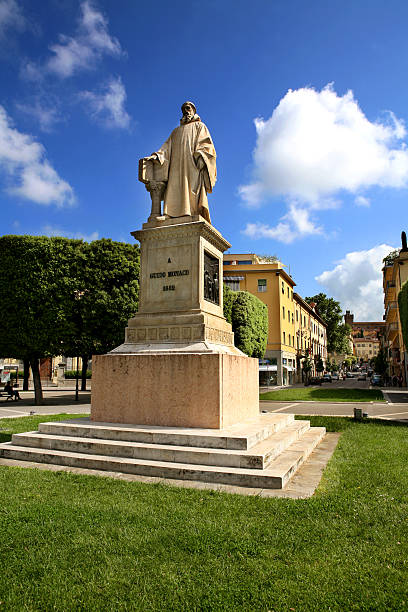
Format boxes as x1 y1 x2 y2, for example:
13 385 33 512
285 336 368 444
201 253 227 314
91 347 259 429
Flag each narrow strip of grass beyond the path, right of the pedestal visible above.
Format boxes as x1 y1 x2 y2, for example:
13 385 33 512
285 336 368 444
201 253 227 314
259 387 385 402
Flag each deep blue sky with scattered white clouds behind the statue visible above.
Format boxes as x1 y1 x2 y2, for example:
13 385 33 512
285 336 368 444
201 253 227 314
0 0 408 320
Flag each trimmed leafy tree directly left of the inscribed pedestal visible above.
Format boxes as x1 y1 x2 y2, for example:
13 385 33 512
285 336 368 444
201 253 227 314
63 238 140 390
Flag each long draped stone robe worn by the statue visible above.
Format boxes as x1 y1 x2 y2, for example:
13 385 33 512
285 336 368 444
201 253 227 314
155 115 217 223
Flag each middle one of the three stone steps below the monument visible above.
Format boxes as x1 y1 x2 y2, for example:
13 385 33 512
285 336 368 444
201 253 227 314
12 420 310 470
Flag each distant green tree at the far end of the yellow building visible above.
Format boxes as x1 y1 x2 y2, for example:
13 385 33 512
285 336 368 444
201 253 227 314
305 293 351 353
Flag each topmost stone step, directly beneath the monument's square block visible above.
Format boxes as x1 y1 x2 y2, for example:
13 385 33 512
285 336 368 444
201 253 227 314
38 414 294 450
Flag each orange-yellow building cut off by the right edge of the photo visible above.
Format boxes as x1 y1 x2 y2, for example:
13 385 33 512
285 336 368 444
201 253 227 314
382 238 408 385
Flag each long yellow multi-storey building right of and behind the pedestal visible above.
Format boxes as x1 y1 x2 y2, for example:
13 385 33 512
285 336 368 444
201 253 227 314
224 253 326 385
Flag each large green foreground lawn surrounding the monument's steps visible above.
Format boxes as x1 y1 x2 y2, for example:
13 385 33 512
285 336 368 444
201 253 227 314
0 416 408 612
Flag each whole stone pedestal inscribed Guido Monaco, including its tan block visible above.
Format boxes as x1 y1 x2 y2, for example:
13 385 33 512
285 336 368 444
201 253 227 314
91 217 259 428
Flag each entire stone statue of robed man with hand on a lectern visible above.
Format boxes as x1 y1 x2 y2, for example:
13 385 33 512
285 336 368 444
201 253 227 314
139 102 217 223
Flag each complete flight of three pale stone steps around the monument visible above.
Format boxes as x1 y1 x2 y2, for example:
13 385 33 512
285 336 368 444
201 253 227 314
0 413 326 489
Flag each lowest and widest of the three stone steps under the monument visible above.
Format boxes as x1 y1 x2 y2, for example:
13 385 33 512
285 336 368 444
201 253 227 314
0 427 325 489
